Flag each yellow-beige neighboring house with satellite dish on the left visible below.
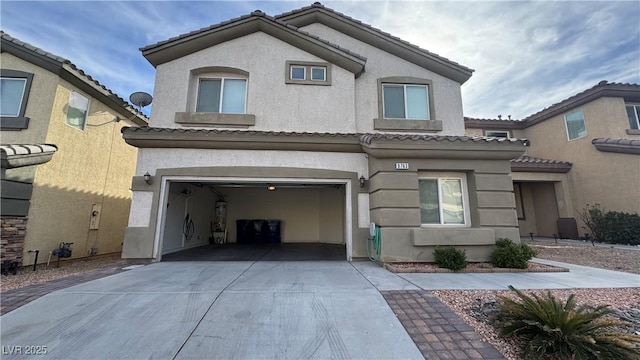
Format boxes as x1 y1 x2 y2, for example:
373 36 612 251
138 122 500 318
0 32 147 265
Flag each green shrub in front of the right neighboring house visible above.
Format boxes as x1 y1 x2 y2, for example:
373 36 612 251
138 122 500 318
578 204 640 245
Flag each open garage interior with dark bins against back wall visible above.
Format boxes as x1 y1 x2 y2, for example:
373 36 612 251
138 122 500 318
161 181 346 261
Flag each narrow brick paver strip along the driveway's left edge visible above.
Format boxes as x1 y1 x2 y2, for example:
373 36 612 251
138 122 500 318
0 264 144 315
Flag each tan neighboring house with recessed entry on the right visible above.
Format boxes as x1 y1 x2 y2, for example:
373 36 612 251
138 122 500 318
465 81 640 238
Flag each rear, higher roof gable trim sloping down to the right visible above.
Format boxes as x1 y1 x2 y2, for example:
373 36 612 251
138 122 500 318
275 2 473 84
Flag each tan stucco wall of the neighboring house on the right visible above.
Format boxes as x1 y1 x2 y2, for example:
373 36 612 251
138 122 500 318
526 98 640 229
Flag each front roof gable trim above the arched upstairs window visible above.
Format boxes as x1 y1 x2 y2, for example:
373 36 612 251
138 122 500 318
140 10 367 76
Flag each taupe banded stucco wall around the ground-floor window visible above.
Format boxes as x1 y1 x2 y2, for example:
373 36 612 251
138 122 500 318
369 157 520 262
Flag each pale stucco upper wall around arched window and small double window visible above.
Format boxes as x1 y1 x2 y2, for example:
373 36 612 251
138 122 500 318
150 32 356 133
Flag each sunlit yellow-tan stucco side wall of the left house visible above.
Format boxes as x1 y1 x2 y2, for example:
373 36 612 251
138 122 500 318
25 78 137 263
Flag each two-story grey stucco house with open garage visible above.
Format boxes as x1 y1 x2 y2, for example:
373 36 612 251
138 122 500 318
123 3 525 261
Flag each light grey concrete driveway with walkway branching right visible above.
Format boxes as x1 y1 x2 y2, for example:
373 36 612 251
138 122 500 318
0 260 640 359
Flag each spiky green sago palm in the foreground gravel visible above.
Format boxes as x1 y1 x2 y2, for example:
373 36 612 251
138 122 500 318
492 286 640 360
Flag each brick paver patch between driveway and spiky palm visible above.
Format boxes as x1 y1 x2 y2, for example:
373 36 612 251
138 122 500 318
380 290 504 360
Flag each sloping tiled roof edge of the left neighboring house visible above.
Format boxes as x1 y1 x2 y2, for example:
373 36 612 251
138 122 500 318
0 31 148 125
